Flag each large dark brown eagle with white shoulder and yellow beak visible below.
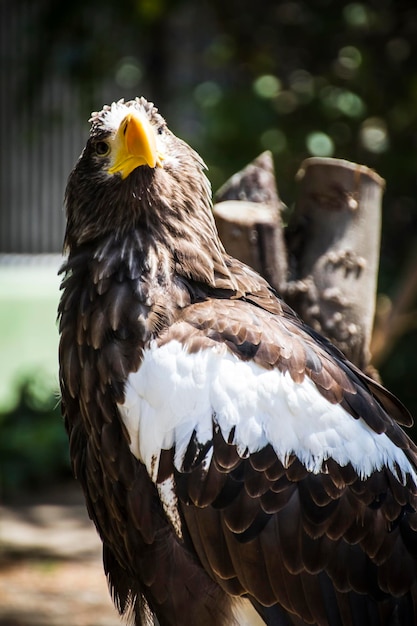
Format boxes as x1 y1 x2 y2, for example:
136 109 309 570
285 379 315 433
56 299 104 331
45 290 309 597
58 98 417 626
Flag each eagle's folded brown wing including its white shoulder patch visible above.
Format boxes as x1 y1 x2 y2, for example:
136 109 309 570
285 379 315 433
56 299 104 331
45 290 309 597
119 299 417 626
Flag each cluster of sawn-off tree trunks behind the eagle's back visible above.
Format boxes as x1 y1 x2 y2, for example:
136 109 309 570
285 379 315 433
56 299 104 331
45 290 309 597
214 153 384 369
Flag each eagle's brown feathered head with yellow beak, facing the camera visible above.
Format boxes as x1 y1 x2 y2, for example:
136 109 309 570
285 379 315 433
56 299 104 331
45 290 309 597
65 98 213 249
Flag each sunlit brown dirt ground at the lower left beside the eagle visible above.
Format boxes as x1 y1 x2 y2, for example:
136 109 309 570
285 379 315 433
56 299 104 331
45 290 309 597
0 484 122 626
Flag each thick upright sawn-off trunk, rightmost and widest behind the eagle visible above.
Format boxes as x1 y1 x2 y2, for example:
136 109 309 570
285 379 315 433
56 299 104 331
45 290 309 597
285 158 384 369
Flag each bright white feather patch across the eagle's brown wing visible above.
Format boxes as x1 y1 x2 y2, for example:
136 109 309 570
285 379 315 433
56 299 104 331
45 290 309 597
119 341 417 483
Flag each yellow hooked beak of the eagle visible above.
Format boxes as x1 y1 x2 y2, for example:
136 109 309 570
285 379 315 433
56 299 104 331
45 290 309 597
108 112 162 178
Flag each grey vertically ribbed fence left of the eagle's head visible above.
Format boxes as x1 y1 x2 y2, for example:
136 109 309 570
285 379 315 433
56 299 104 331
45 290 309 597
0 0 86 253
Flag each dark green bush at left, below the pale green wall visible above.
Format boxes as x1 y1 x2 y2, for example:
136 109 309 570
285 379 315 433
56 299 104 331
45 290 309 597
0 375 71 495
